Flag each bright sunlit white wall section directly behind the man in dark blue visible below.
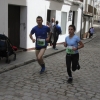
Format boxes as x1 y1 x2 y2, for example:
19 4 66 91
27 0 47 48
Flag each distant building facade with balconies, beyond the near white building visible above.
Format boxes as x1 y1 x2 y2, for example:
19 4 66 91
82 0 97 39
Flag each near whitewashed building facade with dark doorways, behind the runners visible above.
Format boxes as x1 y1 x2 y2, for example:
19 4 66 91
0 0 82 49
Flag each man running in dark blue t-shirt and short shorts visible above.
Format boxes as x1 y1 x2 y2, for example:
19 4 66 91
30 16 50 74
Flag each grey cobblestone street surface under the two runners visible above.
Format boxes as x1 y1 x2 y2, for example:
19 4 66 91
0 30 100 100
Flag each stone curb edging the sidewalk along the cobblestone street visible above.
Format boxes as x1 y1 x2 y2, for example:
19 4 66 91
0 34 96 74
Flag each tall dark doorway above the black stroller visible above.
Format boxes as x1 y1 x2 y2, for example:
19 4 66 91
8 5 20 48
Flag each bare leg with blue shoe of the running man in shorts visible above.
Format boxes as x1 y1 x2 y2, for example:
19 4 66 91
36 48 46 74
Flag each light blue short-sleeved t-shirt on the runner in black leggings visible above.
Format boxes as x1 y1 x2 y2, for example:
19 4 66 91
65 35 80 53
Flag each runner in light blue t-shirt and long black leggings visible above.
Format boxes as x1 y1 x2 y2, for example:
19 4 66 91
64 25 84 83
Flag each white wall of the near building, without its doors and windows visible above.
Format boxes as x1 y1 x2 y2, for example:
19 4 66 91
0 0 81 49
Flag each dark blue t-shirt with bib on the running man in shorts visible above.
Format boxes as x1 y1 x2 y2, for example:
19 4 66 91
31 25 50 48
